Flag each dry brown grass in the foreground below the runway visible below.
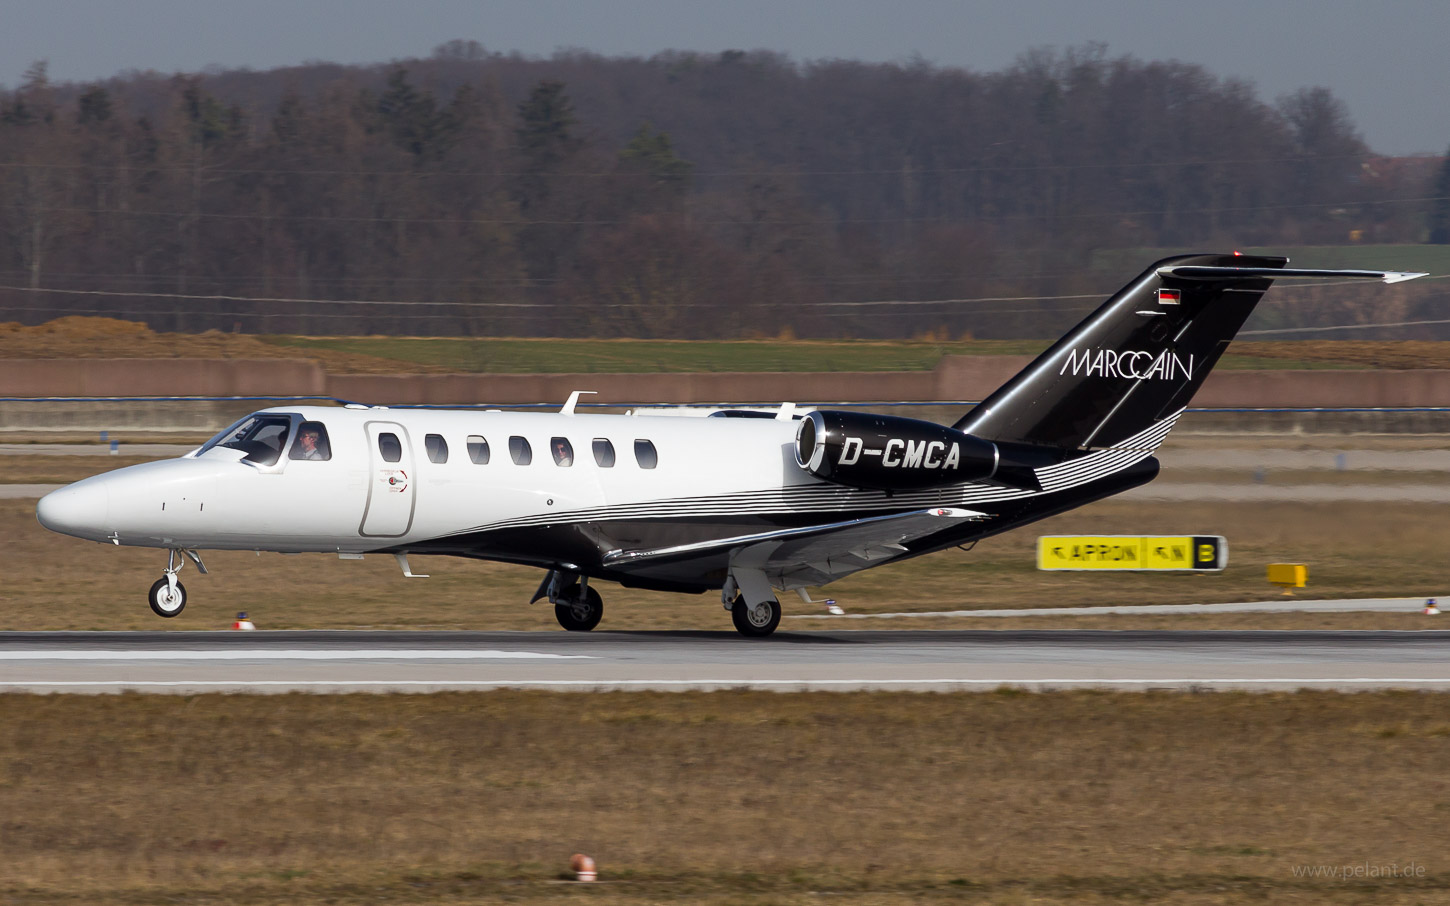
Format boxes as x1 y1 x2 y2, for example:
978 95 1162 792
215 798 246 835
0 693 1450 903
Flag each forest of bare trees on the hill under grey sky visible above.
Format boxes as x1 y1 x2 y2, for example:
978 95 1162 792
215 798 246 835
0 42 1450 338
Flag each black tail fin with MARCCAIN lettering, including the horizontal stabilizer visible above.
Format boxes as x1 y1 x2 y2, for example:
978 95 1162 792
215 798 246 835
953 255 1420 449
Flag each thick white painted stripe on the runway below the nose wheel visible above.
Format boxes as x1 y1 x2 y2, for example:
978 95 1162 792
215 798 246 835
0 648 595 661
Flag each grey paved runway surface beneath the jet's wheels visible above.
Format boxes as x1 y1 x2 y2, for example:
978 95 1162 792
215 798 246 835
0 631 1450 693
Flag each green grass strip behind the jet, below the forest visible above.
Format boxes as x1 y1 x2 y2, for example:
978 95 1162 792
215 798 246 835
262 335 1353 374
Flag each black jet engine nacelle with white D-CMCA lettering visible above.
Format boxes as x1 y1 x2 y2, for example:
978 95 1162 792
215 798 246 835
796 409 1016 491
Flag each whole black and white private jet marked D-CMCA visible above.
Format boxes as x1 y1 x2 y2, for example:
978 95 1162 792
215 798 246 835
38 255 1421 636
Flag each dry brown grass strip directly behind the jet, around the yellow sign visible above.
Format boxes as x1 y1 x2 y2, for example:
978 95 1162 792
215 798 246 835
0 487 1450 631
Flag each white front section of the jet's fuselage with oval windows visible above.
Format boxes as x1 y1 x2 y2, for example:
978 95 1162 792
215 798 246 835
38 407 822 552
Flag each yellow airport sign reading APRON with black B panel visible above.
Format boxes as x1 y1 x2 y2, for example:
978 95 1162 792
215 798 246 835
1037 535 1228 570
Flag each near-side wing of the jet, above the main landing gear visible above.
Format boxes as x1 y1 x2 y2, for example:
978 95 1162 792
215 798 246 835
605 507 987 589
